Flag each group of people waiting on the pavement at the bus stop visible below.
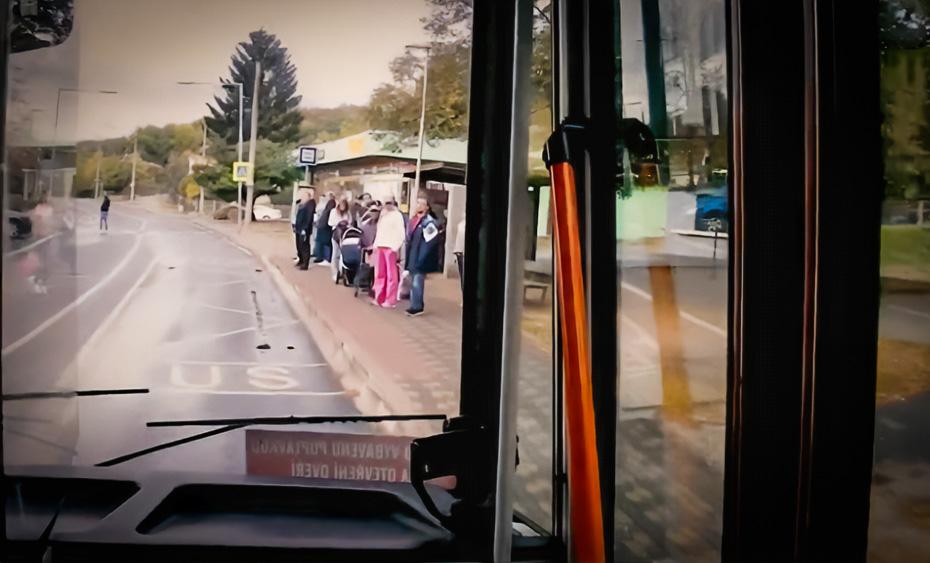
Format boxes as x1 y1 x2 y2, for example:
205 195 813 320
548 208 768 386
292 188 442 316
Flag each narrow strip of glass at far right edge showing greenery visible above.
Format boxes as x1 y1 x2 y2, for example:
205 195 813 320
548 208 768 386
869 1 930 563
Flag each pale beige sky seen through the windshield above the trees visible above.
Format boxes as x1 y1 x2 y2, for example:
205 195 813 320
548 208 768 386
10 0 428 144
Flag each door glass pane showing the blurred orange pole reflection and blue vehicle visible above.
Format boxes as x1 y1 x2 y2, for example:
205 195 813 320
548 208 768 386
615 0 729 562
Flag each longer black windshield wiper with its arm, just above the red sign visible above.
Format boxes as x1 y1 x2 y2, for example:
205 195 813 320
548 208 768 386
96 414 447 467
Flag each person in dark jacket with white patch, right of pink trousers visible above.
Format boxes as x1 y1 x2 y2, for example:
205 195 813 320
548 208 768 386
405 197 442 317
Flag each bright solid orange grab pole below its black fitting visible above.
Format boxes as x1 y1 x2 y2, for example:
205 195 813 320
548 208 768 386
549 162 606 563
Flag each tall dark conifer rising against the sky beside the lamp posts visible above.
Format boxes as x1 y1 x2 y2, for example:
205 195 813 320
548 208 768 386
207 29 301 144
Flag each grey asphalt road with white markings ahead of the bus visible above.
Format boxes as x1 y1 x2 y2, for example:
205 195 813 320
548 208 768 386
2 202 356 473
